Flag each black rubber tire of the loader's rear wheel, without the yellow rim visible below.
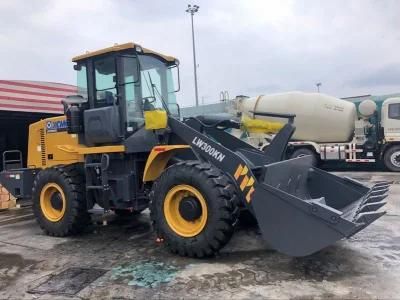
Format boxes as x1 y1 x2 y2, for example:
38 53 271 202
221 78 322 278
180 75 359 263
32 165 90 237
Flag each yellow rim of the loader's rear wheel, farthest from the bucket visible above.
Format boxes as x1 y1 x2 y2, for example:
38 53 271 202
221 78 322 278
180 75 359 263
40 183 66 222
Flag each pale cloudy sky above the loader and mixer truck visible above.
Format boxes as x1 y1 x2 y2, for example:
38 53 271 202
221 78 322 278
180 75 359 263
0 0 400 106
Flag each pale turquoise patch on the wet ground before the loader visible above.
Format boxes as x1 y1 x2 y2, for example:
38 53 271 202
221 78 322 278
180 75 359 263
111 261 178 288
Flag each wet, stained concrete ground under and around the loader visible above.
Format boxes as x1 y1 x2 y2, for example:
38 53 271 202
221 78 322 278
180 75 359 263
0 172 400 299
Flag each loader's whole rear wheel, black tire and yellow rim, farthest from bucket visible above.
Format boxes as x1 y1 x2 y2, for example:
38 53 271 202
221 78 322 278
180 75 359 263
32 165 90 237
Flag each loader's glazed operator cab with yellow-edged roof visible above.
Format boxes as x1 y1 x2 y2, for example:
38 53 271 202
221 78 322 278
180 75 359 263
64 43 179 150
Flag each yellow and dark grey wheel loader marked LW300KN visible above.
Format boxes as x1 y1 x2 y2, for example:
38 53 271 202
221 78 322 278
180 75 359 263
0 43 389 258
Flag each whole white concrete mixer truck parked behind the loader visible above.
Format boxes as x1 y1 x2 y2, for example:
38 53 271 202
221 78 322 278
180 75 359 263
233 92 400 172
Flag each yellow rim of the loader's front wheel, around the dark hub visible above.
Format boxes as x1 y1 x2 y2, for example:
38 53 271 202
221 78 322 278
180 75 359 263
164 184 208 237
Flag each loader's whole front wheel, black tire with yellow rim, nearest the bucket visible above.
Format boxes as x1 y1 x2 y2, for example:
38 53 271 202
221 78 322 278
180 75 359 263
150 161 239 258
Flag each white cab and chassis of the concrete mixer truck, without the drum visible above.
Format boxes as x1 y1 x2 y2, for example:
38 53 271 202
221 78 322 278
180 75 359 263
289 97 400 172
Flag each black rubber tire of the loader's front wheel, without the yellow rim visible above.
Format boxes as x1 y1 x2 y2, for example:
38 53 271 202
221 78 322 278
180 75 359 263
150 161 239 258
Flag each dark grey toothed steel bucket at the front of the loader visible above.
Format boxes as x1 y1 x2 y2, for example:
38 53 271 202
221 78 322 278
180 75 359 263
252 156 389 256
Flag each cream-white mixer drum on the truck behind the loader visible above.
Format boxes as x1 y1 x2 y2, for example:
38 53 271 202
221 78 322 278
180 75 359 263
238 92 357 143
